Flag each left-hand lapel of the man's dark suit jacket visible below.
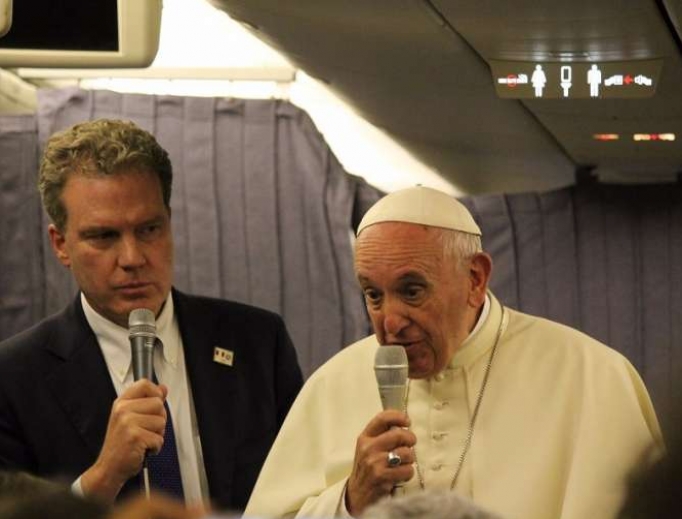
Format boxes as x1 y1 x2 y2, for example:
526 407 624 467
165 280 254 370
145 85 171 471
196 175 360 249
46 295 116 460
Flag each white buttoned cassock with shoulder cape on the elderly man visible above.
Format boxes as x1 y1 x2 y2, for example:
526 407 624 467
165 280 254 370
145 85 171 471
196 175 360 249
245 294 663 519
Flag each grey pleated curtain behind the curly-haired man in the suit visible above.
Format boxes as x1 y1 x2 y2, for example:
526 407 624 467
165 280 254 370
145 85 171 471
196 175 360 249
0 88 381 375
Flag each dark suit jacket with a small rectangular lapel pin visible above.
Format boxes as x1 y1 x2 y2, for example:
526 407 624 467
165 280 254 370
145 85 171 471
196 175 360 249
0 290 302 510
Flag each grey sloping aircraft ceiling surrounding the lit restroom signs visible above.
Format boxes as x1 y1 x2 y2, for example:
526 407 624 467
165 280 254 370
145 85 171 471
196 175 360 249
210 0 682 193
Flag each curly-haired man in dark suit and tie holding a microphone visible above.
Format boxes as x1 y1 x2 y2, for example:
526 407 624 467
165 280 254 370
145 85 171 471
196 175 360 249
0 120 302 510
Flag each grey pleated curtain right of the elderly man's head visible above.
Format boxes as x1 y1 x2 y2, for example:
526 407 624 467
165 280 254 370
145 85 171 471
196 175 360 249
462 181 682 433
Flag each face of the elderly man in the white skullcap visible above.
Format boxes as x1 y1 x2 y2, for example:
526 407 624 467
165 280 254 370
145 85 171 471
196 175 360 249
355 222 489 378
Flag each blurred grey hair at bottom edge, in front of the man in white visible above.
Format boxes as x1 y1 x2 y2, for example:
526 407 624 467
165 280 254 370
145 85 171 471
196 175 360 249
360 490 502 519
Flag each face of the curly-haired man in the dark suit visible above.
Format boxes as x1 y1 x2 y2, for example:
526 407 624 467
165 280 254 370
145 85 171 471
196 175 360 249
49 171 173 327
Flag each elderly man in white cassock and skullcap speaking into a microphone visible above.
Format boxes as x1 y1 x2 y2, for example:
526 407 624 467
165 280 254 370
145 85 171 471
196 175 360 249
246 187 663 519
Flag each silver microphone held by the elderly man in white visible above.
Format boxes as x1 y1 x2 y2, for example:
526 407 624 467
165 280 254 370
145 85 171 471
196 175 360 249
374 346 408 411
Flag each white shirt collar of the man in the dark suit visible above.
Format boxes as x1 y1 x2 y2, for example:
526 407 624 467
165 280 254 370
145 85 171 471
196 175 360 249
81 292 179 381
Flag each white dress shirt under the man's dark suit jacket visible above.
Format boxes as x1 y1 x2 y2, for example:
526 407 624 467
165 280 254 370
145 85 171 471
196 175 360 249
73 293 209 504
